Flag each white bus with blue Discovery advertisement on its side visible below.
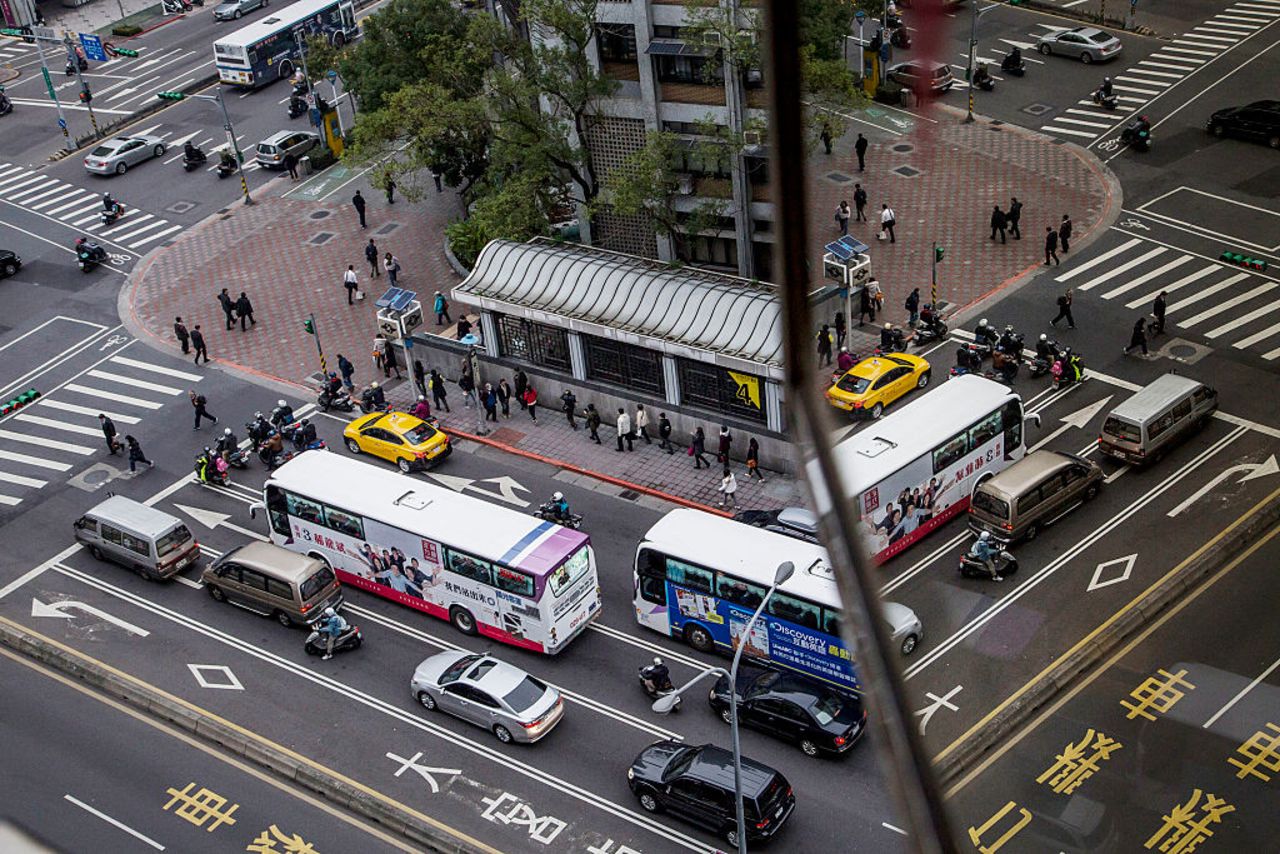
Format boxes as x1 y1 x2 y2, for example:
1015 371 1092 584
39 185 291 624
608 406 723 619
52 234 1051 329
632 508 859 691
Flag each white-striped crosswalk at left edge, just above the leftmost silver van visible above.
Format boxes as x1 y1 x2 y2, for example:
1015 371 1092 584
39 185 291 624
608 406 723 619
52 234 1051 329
0 353 202 508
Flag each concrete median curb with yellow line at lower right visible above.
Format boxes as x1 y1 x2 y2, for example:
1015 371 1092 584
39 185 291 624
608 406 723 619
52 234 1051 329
933 489 1280 786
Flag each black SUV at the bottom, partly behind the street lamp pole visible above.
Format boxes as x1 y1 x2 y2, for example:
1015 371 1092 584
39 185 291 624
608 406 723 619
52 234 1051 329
627 740 796 848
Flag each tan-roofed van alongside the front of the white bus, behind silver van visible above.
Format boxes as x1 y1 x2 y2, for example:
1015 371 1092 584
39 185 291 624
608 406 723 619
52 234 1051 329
200 543 342 626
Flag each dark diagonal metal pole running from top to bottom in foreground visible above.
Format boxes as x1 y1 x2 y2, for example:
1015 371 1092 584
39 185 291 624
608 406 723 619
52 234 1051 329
764 0 957 854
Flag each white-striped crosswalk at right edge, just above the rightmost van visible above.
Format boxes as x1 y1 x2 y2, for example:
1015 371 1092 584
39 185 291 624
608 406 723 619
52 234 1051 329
1055 237 1280 361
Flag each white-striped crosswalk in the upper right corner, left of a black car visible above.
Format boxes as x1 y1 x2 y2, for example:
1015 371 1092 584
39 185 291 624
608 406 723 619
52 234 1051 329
1039 0 1280 145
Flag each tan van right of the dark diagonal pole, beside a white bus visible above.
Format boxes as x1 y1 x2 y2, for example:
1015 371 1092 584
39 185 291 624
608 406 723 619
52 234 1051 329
969 451 1102 544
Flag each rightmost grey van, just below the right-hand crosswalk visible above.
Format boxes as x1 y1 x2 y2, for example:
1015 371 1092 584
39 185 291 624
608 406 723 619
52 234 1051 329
1098 374 1217 466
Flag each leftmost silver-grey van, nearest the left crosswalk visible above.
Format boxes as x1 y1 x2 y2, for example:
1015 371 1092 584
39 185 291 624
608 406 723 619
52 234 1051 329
74 495 200 579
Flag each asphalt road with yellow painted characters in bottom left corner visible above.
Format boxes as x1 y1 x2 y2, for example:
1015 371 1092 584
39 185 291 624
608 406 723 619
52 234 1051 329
0 652 413 854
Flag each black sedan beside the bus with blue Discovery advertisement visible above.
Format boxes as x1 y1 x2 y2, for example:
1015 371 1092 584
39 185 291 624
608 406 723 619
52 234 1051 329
708 665 867 757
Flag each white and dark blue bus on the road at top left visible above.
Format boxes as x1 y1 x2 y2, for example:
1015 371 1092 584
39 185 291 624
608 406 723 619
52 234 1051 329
214 0 360 88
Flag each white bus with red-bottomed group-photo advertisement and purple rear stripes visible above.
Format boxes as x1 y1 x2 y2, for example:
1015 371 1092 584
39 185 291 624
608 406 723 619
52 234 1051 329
253 451 600 654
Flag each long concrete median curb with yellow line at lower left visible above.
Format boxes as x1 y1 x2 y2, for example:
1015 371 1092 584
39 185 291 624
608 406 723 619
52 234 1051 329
0 617 495 854
